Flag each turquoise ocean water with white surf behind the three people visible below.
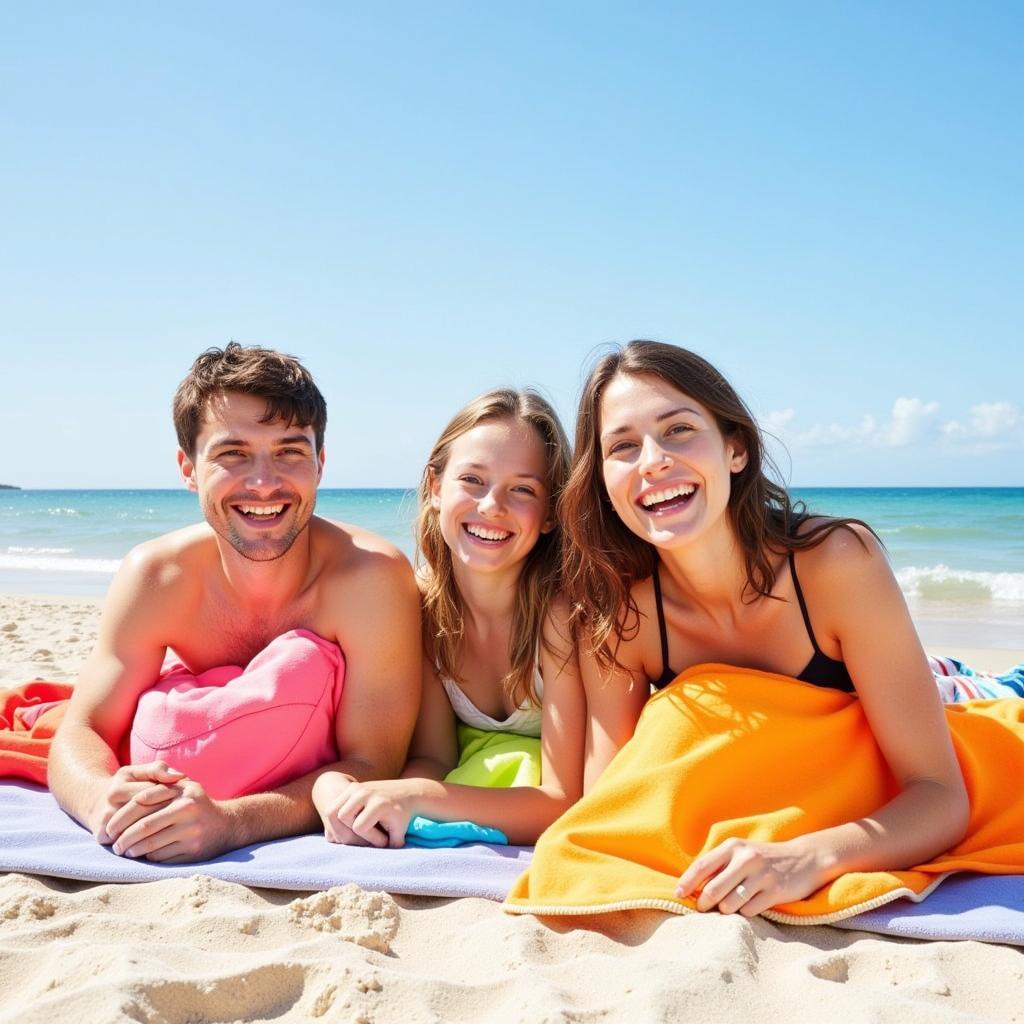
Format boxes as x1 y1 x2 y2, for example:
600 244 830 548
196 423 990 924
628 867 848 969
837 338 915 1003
0 487 1024 614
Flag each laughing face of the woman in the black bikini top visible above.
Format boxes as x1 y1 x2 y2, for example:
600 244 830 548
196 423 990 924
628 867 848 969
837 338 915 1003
598 373 746 548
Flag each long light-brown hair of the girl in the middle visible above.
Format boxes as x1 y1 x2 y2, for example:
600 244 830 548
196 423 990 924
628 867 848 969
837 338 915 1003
416 388 569 708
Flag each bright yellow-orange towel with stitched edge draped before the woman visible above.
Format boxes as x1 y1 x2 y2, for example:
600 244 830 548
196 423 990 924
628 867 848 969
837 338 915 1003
505 665 1024 924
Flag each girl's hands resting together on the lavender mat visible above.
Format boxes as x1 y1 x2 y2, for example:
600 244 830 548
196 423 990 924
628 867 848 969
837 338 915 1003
313 772 416 848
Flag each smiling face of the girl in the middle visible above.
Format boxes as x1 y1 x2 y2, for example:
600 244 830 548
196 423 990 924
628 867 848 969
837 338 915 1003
430 419 553 572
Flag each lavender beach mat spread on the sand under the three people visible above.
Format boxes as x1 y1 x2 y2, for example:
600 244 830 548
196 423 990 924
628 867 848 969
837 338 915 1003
0 782 1024 946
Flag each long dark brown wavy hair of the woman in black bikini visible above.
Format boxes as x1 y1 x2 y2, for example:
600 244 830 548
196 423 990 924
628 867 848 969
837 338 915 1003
558 341 873 665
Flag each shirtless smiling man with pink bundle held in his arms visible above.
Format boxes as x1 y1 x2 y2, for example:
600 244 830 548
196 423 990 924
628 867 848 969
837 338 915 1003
49 342 421 862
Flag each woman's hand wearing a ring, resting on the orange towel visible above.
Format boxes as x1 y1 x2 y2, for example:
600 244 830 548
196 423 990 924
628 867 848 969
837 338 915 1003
676 836 829 918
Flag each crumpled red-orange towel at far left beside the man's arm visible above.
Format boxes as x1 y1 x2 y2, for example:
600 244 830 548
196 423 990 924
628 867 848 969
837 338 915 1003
0 680 72 785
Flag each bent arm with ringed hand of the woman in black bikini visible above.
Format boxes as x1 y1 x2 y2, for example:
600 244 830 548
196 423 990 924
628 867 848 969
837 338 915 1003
677 528 969 915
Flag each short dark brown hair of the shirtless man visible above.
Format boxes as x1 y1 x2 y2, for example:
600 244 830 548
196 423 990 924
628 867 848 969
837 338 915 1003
173 341 327 458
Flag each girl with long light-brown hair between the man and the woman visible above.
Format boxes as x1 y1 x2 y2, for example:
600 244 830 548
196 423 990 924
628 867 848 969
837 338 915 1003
314 389 586 846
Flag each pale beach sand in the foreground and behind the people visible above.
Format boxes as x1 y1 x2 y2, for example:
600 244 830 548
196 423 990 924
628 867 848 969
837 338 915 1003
0 595 1024 1024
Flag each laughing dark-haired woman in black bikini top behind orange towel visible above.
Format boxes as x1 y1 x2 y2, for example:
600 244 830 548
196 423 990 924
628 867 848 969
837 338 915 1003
559 341 969 915
